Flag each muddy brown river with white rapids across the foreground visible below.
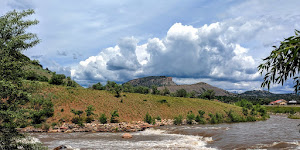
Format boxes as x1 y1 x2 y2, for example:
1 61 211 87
30 115 300 150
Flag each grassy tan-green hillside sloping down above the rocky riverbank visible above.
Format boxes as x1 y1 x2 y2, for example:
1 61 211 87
28 82 242 122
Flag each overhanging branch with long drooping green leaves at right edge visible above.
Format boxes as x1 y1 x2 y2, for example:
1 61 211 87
258 30 300 93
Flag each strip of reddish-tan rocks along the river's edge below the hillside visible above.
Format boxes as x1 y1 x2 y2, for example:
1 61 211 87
18 119 174 133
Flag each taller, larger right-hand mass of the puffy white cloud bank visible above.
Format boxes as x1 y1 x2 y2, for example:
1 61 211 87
144 23 256 80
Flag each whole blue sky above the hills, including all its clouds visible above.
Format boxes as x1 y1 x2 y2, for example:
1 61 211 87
0 0 300 93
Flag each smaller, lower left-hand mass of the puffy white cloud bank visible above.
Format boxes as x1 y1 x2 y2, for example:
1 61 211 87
72 38 144 85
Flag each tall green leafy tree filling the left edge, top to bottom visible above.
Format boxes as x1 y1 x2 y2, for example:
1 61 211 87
0 10 44 149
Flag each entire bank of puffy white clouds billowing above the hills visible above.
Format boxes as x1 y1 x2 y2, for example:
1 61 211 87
74 23 258 86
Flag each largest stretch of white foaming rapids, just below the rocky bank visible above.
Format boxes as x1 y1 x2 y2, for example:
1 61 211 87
44 128 215 150
